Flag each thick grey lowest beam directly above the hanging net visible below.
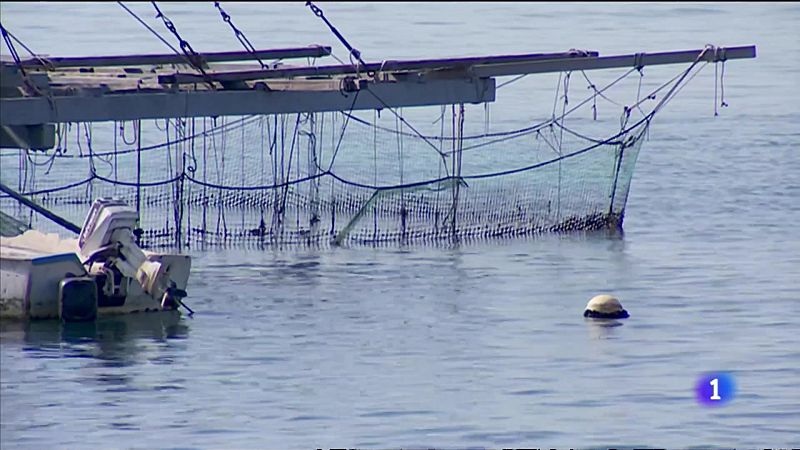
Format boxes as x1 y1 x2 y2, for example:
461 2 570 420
0 78 495 125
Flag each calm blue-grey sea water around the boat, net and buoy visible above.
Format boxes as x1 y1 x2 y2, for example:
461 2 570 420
0 2 800 448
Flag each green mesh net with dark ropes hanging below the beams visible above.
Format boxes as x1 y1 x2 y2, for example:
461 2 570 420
0 55 712 247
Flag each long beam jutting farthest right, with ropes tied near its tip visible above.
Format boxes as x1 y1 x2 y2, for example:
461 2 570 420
472 45 756 77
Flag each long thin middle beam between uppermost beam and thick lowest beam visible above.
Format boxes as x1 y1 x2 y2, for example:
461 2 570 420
158 51 598 84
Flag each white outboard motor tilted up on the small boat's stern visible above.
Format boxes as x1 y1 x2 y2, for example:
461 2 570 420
78 198 186 309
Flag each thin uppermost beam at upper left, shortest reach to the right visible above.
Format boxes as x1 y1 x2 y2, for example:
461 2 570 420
15 45 331 68
